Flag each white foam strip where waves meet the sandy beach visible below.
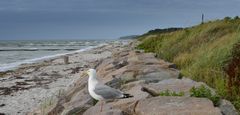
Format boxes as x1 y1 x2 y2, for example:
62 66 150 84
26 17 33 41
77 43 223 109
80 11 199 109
0 43 106 72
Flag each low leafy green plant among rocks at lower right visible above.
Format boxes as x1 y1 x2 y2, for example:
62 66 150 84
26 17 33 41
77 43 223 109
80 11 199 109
190 85 220 106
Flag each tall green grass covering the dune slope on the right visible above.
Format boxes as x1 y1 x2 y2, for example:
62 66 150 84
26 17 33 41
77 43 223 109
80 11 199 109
138 17 240 110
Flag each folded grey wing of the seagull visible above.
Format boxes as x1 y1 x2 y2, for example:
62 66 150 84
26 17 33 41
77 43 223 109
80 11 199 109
94 84 123 99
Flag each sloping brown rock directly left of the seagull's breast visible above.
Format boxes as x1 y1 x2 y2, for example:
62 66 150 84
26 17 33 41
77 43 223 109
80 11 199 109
48 77 91 115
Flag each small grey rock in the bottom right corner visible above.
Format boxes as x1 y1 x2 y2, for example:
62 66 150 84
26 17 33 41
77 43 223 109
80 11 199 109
219 99 238 115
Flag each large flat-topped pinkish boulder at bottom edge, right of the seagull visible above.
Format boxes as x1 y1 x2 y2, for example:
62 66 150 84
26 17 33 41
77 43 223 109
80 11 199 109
134 97 221 115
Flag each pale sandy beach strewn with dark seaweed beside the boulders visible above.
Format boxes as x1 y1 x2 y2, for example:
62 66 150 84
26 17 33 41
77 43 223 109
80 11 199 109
0 42 129 115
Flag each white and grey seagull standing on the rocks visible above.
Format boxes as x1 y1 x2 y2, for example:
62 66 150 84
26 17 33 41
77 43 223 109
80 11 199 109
84 69 133 112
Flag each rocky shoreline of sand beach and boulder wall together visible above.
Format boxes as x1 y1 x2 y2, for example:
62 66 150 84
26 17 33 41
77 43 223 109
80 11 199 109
0 41 238 115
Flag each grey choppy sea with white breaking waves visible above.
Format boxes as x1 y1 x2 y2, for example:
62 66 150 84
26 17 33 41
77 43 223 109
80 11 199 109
0 40 120 72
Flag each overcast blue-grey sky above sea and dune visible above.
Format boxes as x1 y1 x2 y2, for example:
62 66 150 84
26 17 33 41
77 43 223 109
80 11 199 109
0 0 240 40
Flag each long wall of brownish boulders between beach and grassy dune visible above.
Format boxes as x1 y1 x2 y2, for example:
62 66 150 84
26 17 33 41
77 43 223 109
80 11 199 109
26 41 236 115
